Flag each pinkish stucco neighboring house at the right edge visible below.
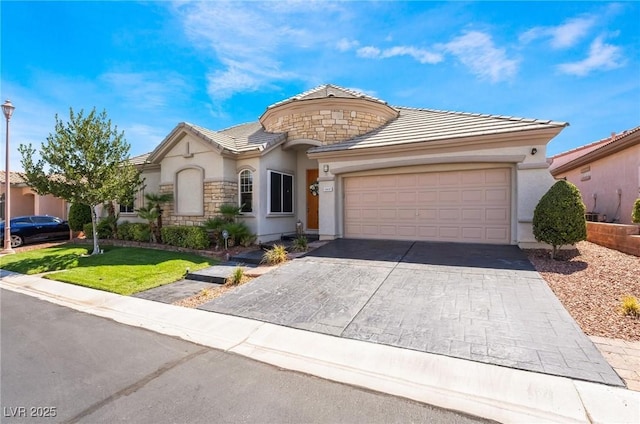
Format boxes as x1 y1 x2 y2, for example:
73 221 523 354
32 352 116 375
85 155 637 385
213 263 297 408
549 127 640 224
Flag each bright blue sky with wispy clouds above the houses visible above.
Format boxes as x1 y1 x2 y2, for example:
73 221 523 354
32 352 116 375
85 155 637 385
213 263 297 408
0 0 640 170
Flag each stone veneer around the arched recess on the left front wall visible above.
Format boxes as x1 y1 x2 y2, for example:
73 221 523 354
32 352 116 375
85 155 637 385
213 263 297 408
160 181 238 226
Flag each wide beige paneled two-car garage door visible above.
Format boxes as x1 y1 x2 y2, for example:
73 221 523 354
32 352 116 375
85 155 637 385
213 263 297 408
344 168 511 244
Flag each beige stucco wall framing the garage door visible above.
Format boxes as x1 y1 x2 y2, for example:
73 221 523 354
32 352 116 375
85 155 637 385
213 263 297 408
312 136 554 246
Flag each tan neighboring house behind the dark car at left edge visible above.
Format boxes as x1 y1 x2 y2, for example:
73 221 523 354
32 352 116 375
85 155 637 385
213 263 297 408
0 171 67 219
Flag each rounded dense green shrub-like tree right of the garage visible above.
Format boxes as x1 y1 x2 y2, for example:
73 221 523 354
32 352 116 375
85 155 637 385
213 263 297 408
533 180 587 258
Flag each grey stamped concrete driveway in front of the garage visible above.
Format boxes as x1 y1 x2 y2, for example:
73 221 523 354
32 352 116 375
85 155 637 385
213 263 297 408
200 239 624 386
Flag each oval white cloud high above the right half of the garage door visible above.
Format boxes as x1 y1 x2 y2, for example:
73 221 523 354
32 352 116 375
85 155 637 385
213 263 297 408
441 31 518 82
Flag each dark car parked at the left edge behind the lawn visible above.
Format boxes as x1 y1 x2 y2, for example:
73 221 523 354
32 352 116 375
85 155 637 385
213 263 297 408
0 215 71 247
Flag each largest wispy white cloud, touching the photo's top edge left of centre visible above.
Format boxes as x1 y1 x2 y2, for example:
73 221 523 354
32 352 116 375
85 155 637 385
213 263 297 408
174 1 344 101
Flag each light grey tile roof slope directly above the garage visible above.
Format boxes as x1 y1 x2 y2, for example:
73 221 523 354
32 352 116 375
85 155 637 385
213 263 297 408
310 107 568 152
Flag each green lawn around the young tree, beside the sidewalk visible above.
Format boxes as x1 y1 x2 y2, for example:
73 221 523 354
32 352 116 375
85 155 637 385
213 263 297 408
0 245 217 295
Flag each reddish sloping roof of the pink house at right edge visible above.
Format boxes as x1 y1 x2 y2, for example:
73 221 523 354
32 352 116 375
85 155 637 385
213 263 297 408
549 126 640 175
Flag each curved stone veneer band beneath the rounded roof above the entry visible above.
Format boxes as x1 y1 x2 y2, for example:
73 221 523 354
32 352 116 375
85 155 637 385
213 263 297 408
264 109 388 144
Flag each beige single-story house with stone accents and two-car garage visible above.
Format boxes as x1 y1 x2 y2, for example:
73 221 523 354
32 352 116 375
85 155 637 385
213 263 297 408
129 85 567 245
